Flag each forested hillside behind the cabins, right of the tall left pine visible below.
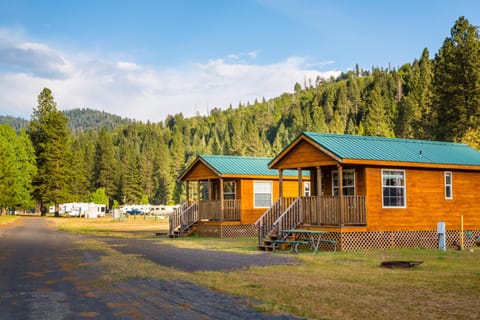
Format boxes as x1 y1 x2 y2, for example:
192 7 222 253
0 17 480 212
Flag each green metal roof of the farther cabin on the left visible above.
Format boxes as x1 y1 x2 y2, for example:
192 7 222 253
199 155 308 177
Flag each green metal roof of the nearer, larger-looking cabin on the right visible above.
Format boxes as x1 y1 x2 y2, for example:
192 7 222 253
302 132 480 166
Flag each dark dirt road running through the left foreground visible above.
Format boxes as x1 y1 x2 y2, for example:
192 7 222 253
0 218 298 320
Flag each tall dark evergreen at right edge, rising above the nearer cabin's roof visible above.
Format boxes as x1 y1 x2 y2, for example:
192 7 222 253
434 17 480 141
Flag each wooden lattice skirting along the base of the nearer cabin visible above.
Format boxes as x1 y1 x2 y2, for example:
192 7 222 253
336 230 480 251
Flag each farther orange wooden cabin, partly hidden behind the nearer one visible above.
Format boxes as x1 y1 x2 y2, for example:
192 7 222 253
169 155 310 237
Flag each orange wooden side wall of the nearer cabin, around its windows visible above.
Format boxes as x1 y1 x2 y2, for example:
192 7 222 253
366 167 480 231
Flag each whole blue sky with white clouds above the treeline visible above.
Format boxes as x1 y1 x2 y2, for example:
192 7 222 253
0 0 480 122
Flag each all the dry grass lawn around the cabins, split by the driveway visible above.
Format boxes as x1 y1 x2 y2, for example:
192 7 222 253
52 217 480 319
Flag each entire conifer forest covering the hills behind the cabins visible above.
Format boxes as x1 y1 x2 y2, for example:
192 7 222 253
0 17 480 213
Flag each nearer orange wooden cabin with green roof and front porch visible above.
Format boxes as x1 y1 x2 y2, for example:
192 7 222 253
256 132 480 251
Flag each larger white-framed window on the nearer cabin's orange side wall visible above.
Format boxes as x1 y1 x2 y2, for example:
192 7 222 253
382 170 406 208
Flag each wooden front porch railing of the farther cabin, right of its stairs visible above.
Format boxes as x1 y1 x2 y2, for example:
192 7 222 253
198 200 240 221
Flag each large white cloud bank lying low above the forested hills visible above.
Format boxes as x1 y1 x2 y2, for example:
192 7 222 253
0 32 339 122
